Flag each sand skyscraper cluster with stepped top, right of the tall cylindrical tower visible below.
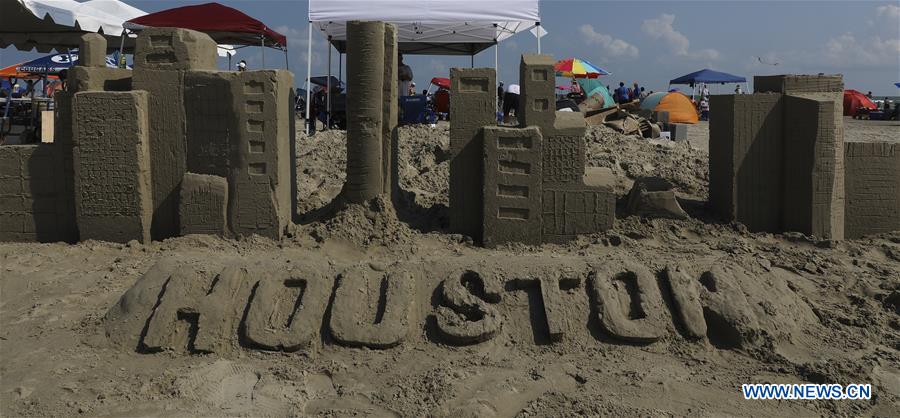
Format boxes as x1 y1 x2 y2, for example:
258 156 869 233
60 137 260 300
450 54 615 247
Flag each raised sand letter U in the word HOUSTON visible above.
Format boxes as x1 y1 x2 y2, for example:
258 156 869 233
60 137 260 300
329 265 416 348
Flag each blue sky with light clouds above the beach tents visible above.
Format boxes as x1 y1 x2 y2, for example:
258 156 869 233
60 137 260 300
0 0 900 95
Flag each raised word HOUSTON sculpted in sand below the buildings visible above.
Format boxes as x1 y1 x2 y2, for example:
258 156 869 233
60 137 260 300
104 257 815 354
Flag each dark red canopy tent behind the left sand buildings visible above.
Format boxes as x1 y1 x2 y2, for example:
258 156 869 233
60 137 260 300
122 3 287 64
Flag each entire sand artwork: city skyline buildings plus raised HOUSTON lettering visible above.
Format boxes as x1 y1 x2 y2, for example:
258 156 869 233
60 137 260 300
0 22 900 353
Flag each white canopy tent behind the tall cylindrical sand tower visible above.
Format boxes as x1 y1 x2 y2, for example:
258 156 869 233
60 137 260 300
306 0 541 129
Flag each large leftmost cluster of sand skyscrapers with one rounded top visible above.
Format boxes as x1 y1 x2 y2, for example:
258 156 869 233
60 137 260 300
0 28 294 242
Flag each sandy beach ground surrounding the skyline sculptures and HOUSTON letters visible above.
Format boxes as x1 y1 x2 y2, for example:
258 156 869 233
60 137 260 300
0 119 900 417
